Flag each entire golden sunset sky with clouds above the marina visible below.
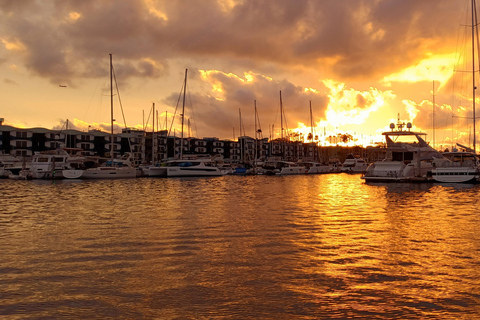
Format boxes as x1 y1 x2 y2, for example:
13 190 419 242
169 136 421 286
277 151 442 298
0 0 478 147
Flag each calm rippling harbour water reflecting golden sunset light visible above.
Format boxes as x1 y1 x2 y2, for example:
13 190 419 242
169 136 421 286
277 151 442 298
0 174 480 320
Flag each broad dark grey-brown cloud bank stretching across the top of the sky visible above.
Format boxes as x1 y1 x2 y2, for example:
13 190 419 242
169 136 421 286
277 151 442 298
0 0 459 82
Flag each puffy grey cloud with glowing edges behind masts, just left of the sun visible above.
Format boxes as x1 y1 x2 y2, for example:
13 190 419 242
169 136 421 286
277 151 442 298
164 70 327 137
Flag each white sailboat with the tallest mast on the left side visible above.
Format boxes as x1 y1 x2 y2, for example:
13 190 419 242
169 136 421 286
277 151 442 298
62 53 137 179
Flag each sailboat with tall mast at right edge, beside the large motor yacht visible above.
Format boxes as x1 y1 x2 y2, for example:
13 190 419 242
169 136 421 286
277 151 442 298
432 0 480 183
